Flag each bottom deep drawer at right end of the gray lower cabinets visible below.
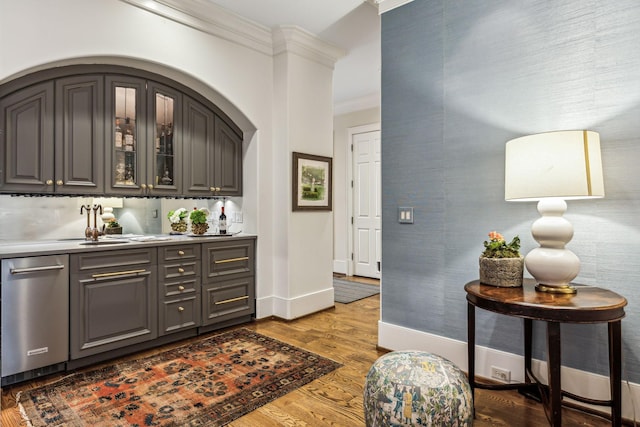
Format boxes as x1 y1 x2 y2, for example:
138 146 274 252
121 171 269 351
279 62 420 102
202 276 256 326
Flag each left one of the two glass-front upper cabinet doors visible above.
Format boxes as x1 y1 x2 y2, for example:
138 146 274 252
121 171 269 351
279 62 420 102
107 77 147 195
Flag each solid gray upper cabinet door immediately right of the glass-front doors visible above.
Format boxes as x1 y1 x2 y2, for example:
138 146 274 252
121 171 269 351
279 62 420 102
182 97 215 197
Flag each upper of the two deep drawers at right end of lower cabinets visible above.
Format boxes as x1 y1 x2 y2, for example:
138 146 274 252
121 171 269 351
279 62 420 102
202 240 255 280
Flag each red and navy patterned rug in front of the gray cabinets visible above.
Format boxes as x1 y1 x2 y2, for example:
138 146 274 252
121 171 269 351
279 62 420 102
18 329 341 427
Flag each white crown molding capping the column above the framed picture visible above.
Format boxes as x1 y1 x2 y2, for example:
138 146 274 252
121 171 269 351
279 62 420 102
273 25 346 69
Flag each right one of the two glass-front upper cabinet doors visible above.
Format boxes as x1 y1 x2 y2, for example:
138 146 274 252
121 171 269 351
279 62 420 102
147 82 182 196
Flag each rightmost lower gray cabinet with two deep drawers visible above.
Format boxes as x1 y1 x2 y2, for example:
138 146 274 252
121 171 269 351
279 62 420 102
202 238 255 329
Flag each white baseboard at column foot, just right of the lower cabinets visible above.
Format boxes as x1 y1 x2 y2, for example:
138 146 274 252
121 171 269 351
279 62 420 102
256 286 334 320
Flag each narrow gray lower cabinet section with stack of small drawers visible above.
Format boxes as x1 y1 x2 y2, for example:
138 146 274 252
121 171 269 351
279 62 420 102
158 244 202 335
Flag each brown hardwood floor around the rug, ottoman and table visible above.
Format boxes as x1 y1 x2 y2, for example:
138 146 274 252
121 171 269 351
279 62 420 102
0 281 609 427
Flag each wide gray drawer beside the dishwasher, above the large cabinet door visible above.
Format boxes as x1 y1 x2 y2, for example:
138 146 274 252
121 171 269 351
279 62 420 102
70 248 157 274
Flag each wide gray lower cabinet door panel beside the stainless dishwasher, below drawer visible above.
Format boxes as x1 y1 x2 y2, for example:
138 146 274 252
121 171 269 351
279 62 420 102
70 269 158 359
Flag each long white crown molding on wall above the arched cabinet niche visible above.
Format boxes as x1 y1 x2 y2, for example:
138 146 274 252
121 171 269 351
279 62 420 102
120 0 273 56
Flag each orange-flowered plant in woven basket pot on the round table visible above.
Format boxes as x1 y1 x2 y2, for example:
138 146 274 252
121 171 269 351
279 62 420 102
480 231 524 288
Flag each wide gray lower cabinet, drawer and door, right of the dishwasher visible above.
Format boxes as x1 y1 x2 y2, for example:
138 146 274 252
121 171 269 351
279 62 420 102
70 248 158 360
